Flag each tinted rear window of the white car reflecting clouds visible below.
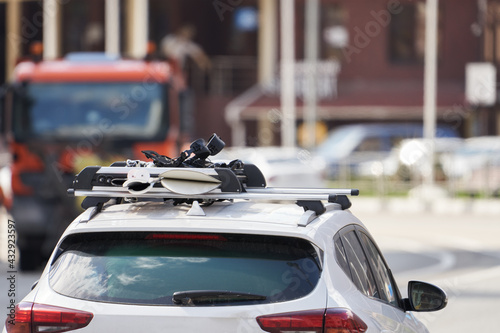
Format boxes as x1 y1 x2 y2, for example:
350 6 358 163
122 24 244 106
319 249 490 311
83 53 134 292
49 232 321 306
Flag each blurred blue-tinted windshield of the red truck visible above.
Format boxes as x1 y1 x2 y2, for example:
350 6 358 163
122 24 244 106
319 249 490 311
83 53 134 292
14 82 166 139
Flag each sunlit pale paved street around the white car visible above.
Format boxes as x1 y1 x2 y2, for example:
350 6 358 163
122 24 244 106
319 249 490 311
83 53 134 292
0 199 500 333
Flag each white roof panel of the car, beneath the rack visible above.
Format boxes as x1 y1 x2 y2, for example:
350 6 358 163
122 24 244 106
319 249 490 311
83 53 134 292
63 200 360 245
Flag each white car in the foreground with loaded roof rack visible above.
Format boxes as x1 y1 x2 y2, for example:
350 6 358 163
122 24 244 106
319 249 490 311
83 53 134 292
4 150 447 333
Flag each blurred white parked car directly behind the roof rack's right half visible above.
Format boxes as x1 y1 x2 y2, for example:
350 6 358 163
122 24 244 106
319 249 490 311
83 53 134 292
213 147 326 187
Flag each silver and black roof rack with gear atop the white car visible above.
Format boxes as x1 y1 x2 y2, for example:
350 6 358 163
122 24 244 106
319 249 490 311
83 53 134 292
68 136 359 215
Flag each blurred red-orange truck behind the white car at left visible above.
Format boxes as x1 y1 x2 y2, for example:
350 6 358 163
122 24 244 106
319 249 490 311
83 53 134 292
1 53 179 270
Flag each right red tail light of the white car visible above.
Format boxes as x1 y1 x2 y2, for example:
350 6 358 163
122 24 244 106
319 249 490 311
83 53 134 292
257 308 368 333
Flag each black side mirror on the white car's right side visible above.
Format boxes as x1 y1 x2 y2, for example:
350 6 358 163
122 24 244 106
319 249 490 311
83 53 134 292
404 281 448 312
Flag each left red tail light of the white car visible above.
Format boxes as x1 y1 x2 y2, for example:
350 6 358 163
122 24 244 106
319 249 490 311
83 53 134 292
5 302 94 333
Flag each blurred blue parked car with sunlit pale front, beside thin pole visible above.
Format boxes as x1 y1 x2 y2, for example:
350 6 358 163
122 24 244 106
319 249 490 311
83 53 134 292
316 123 458 178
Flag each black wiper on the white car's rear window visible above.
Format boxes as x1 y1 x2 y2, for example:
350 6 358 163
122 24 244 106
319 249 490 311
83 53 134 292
172 290 267 305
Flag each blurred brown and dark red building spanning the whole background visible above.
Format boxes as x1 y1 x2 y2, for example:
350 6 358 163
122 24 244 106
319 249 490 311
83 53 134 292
0 0 500 145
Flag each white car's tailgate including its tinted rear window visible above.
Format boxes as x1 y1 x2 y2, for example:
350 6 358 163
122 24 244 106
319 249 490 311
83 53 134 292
36 232 326 332
